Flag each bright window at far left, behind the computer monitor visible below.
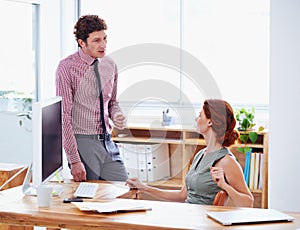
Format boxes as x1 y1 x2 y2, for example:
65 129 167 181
0 0 38 111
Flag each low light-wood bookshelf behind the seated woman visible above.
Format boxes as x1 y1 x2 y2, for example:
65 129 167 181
113 124 268 208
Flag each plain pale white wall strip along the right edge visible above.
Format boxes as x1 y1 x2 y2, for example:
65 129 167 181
269 0 300 212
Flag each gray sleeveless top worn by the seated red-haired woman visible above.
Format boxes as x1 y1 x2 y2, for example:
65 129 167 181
185 148 232 205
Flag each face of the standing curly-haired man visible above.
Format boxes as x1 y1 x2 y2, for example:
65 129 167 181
79 30 107 58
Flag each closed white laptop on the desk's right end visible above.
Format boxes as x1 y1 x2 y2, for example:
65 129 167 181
206 208 294 225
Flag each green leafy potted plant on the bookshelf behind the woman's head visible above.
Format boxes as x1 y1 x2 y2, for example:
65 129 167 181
235 107 264 153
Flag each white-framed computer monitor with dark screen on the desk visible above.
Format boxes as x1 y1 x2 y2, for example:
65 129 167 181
23 97 63 195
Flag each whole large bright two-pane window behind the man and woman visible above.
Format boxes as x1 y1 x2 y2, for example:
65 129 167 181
81 0 269 126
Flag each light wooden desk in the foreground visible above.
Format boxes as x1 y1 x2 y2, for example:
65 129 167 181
0 183 300 230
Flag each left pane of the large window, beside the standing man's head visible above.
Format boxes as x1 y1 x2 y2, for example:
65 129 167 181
81 0 180 102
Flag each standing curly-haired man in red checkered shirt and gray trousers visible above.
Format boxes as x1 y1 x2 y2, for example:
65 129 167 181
56 15 127 181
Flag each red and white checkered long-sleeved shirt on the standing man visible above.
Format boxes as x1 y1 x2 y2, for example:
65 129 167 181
56 49 121 164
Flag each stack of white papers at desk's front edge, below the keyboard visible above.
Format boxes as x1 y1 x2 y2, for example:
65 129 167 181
72 199 152 213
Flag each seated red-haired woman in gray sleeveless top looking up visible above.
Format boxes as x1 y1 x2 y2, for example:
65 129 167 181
126 99 254 207
